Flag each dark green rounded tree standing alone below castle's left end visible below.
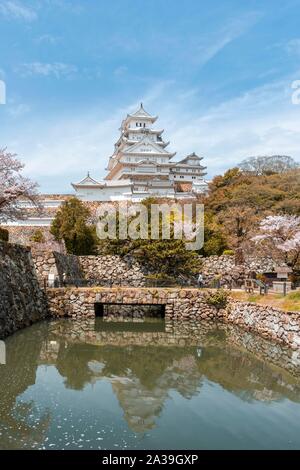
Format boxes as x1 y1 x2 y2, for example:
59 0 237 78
50 197 97 255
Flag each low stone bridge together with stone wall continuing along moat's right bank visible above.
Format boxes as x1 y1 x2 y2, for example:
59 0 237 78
47 287 300 350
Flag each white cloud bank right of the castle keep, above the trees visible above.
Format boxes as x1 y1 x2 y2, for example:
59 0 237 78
162 80 300 176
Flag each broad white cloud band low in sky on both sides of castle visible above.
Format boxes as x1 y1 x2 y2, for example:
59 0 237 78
5 80 300 192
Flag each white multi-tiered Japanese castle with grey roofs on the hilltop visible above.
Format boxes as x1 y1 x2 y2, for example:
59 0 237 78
72 103 207 201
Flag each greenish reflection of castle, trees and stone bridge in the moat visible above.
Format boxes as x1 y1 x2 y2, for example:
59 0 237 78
41 319 300 432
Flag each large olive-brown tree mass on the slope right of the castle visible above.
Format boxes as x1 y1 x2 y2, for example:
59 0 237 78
200 168 300 254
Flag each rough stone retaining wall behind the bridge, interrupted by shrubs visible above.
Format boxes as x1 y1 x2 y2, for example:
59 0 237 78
28 249 282 287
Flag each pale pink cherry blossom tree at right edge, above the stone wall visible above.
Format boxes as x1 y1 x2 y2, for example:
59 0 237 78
252 215 300 268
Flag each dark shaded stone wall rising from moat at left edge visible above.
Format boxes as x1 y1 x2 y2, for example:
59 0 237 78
0 242 48 339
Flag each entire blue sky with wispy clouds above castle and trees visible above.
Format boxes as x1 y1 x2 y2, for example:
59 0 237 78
0 0 300 192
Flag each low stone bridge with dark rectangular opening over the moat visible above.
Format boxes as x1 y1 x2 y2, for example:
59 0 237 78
47 287 220 320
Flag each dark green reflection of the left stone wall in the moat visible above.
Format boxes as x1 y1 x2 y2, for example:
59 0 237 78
0 323 51 449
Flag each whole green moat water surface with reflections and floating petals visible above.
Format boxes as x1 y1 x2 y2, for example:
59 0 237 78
0 318 300 450
